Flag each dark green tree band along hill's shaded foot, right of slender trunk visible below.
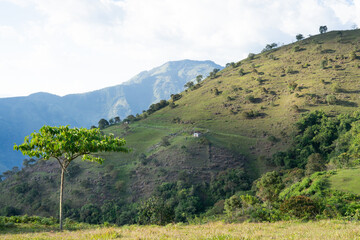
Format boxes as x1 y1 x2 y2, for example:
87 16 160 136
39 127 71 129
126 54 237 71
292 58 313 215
65 168 252 225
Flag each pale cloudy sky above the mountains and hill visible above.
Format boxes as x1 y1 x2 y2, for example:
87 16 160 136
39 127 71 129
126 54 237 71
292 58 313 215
0 0 360 97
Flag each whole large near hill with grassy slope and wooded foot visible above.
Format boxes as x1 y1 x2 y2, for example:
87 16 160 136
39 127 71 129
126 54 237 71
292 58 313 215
0 30 360 225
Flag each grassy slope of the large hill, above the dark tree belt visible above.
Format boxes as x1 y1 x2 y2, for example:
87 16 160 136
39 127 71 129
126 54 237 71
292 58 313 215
0 30 360 213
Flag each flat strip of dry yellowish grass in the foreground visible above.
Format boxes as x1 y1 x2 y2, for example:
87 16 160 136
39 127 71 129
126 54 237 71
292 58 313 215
0 220 360 240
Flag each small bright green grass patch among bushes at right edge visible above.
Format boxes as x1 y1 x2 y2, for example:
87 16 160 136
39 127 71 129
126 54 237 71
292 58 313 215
329 167 360 194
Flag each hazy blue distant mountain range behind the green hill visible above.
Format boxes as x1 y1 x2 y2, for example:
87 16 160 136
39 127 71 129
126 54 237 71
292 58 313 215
0 60 222 172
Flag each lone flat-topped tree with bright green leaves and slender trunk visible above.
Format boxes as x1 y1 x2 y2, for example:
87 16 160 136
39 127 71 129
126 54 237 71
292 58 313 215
14 126 129 230
